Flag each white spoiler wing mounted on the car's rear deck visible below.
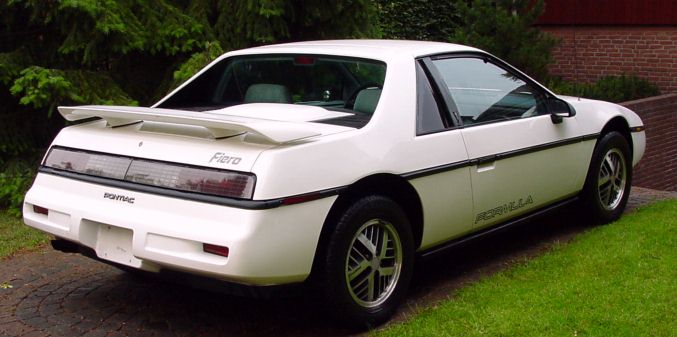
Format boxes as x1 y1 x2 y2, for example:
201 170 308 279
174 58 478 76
59 105 322 144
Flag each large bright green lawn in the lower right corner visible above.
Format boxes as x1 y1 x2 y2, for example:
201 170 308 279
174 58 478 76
372 200 677 337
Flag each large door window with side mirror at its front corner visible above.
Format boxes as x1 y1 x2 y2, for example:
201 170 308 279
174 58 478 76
433 58 546 125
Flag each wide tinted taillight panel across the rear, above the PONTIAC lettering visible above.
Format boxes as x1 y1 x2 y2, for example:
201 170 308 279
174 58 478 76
44 147 256 199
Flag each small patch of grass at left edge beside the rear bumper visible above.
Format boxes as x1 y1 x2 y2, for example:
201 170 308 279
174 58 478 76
0 211 49 259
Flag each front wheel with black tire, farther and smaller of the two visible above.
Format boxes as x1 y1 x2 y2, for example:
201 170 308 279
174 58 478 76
581 131 632 224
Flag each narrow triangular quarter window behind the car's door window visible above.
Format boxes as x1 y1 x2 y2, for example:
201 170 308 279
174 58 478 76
416 63 444 135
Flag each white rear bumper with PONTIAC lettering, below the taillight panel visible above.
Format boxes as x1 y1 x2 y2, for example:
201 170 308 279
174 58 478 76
23 173 336 285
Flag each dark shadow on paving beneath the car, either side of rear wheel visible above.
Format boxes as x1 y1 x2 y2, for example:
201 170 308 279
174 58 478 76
116 205 589 336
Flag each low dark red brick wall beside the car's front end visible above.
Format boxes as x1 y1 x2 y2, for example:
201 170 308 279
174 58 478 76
621 94 677 191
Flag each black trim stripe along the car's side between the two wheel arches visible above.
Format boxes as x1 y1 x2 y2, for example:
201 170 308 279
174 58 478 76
400 133 599 179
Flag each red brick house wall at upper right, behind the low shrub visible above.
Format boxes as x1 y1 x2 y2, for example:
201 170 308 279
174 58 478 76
539 26 677 93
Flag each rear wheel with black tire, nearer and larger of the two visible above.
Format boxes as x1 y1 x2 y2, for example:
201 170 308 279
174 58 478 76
320 195 414 329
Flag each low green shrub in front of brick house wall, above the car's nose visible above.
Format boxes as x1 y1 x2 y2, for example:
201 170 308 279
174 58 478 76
546 74 660 103
